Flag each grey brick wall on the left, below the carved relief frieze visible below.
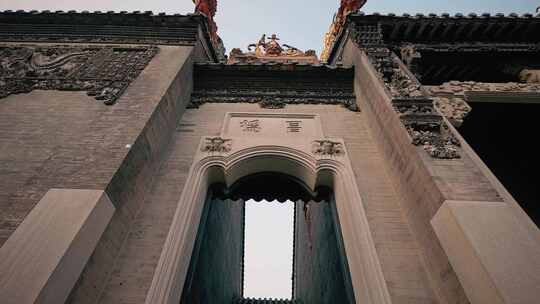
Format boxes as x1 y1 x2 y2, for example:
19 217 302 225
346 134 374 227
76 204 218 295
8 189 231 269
0 47 193 303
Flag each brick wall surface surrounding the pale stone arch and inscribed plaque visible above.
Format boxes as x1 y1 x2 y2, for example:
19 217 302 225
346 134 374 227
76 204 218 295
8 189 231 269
95 103 435 304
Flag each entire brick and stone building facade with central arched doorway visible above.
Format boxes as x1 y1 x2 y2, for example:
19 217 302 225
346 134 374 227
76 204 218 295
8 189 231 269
0 1 540 304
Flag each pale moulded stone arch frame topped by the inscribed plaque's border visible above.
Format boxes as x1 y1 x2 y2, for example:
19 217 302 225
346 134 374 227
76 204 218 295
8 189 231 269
146 113 391 304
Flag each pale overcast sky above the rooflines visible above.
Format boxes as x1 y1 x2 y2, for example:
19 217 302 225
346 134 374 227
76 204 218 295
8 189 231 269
0 0 540 54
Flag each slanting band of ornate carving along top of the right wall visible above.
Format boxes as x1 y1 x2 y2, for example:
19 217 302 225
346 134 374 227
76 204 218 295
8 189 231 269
353 26 460 159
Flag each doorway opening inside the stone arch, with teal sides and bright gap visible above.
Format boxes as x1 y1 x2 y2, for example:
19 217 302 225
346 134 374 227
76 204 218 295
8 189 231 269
181 172 355 304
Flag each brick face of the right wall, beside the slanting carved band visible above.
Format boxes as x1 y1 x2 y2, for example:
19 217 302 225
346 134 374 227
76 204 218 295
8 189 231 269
344 42 502 303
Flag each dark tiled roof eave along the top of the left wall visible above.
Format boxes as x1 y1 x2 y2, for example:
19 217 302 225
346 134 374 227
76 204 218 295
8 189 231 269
0 10 219 61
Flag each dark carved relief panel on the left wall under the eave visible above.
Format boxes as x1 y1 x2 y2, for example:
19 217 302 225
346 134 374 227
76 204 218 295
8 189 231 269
0 46 158 105
